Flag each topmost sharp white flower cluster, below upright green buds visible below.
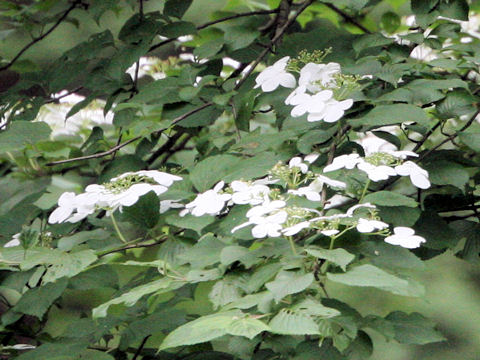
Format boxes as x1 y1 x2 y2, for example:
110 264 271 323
255 56 353 123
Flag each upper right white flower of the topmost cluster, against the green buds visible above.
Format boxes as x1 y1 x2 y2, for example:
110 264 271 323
298 63 340 93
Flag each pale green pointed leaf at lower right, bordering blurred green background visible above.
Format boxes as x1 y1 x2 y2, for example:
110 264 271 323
327 264 424 296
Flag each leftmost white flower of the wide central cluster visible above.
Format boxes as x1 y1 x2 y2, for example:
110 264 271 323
180 181 232 216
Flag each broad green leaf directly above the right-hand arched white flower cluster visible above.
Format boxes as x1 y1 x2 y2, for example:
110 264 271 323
349 104 429 127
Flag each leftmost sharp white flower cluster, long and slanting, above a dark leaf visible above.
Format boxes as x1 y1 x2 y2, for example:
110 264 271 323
48 170 183 224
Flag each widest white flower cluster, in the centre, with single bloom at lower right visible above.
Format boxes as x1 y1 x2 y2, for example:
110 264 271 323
180 152 425 248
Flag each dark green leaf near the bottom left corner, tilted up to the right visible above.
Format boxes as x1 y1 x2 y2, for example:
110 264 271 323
12 278 68 319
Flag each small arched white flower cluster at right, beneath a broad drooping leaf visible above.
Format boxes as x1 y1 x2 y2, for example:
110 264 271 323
323 150 430 189
